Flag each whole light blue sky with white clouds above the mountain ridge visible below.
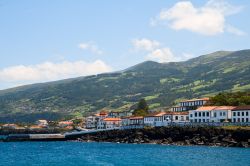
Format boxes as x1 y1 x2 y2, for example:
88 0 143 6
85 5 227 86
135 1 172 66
0 0 250 89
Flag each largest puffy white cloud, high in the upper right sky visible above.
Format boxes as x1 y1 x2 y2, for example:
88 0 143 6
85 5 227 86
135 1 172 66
150 0 242 36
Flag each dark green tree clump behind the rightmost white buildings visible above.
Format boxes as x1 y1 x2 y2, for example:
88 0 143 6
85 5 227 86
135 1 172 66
209 92 250 106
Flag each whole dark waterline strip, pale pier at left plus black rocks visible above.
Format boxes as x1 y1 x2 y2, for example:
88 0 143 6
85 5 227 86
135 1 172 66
0 126 250 148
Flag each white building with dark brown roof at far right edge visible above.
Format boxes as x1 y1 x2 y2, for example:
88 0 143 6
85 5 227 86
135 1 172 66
232 106 250 123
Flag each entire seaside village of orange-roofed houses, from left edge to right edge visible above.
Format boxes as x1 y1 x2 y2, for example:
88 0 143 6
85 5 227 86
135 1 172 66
0 98 250 132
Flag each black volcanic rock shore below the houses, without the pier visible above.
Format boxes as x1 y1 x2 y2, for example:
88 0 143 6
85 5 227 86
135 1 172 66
75 127 250 148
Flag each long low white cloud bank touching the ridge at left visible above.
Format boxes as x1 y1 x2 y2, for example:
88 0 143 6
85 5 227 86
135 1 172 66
0 60 112 87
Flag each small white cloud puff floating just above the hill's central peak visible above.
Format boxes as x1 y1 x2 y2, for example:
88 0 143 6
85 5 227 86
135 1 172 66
132 38 160 51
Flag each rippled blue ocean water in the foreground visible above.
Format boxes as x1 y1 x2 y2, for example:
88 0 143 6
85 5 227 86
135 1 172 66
0 142 250 166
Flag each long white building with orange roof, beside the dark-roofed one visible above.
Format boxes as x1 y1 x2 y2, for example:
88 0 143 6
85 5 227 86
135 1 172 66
189 106 234 123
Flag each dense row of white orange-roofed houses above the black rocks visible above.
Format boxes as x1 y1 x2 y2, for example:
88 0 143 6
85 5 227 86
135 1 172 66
86 98 250 129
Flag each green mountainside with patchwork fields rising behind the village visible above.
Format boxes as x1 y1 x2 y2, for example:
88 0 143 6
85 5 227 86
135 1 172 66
0 50 250 122
